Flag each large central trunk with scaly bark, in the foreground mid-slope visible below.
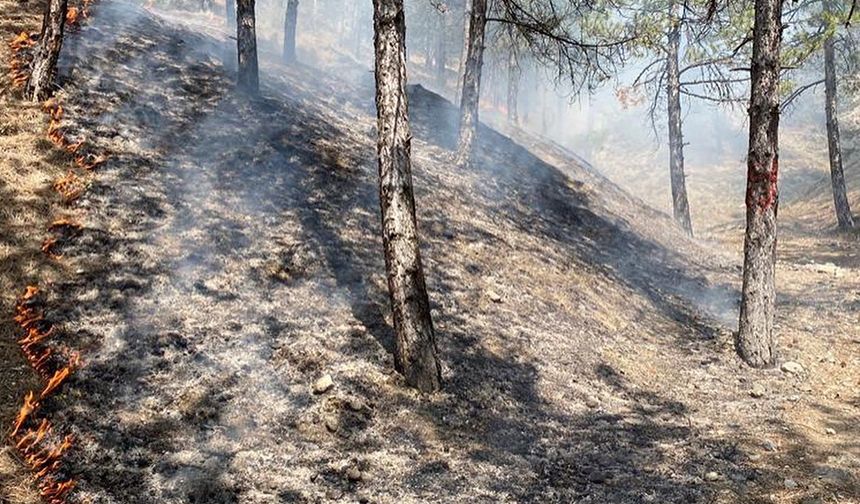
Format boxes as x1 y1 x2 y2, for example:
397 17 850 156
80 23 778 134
373 0 442 392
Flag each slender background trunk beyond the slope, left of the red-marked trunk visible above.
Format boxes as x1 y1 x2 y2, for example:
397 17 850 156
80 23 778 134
666 19 693 236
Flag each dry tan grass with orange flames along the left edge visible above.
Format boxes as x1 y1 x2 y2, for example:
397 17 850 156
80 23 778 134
0 0 106 504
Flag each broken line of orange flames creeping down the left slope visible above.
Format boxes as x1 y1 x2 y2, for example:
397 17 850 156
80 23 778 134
9 0 100 504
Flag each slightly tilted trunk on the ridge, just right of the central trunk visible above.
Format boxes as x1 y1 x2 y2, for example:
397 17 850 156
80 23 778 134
456 0 487 166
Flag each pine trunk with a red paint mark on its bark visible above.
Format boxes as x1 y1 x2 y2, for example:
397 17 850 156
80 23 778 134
737 0 782 367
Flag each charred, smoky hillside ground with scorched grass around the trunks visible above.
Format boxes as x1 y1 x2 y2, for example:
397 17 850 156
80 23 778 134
0 0 860 504
